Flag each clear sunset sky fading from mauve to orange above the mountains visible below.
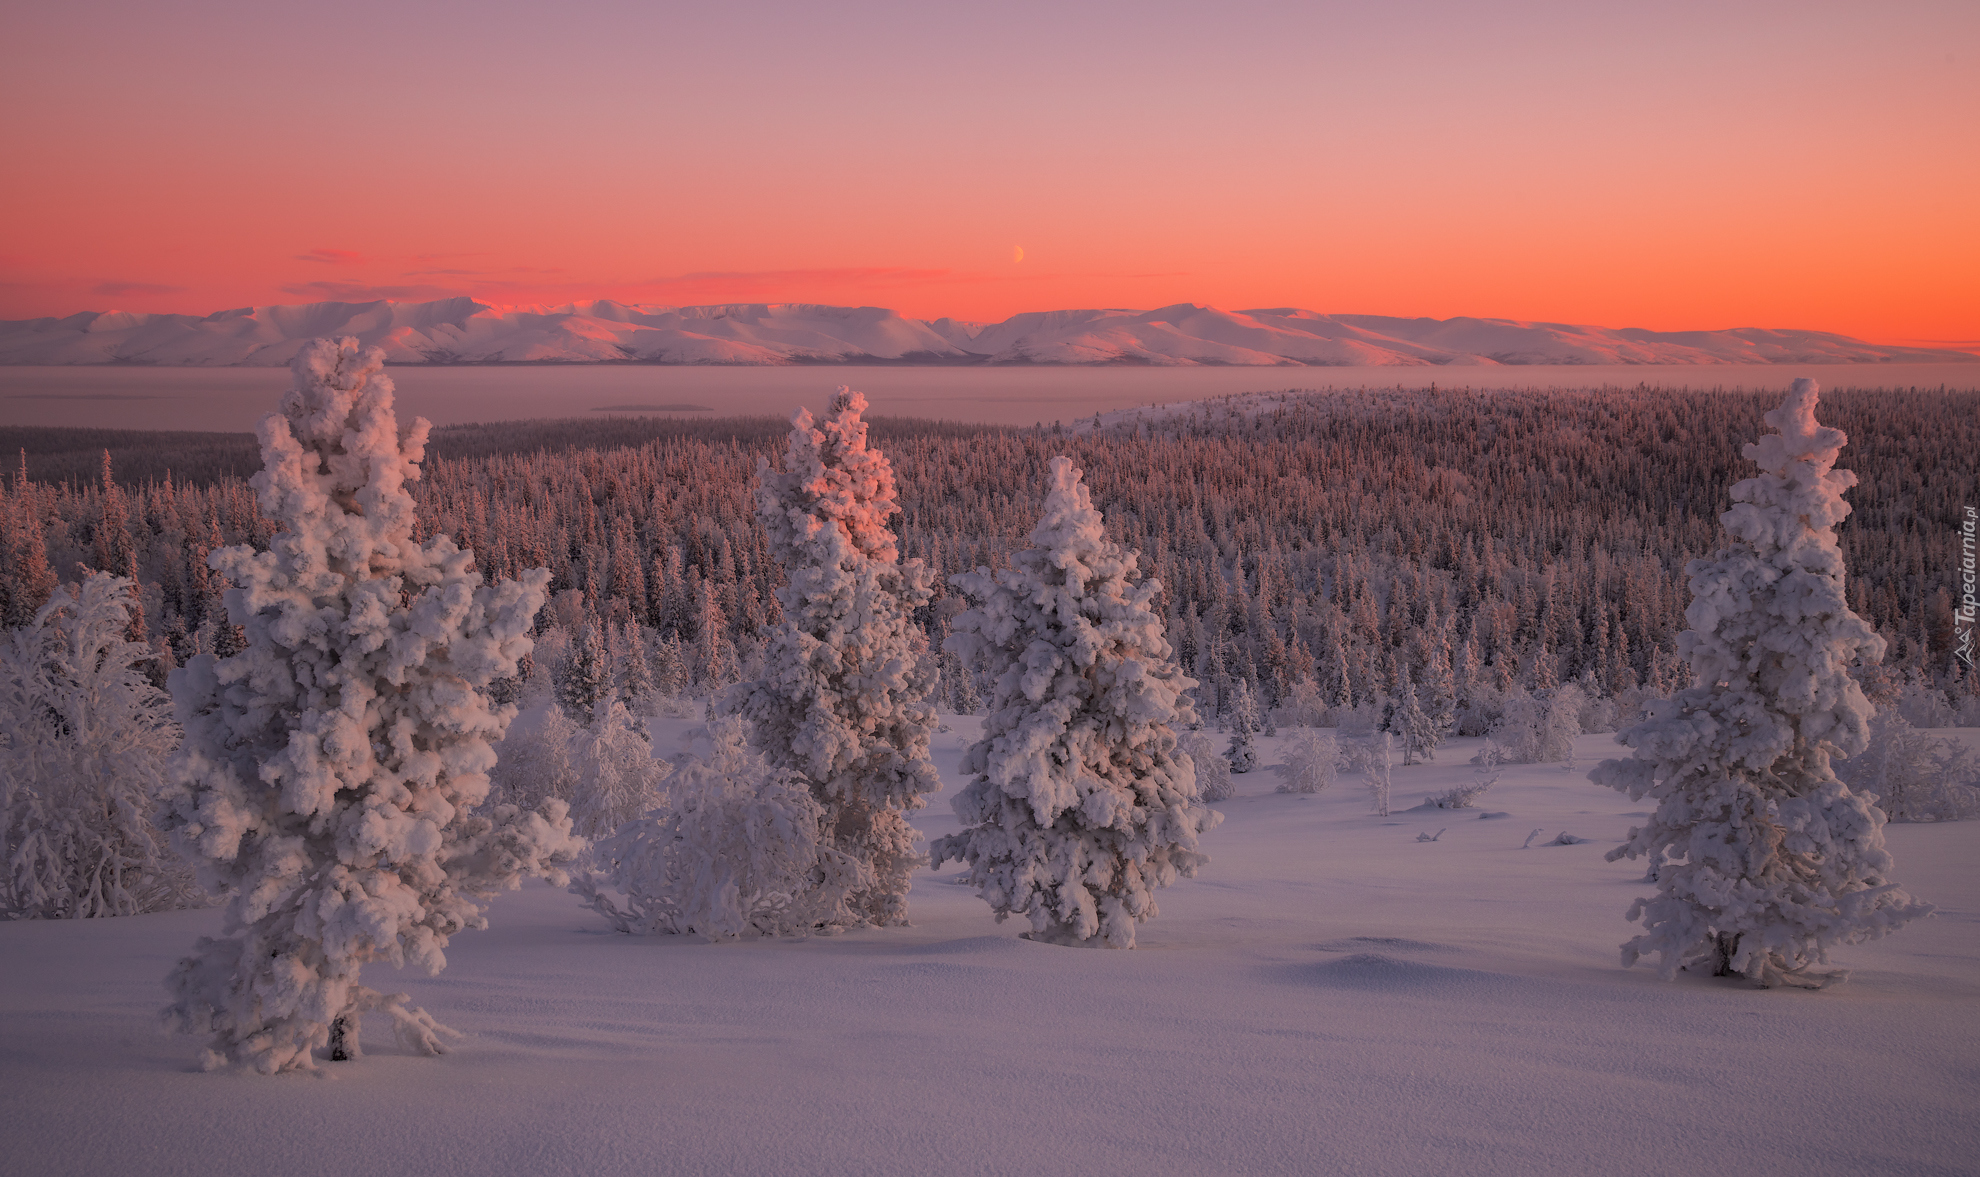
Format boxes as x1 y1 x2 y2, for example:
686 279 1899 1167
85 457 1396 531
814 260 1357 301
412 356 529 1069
0 0 1980 349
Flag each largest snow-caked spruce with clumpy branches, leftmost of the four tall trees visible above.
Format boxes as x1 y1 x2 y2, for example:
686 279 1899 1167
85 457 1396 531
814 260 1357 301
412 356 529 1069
166 339 580 1072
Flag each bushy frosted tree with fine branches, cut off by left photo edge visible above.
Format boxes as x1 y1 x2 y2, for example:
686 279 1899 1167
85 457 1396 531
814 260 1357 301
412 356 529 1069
0 573 198 919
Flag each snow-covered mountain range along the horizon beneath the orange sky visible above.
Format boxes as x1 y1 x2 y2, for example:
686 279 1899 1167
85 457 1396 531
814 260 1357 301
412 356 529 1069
0 297 1980 367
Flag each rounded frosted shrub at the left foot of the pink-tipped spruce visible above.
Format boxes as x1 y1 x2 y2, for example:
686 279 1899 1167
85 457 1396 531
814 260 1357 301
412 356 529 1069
570 719 871 941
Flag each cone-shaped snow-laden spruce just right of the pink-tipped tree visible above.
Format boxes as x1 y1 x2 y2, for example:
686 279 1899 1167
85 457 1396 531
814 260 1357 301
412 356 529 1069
933 458 1222 947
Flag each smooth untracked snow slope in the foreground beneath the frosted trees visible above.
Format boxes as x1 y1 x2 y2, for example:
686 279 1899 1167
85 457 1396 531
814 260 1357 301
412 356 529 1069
0 719 1980 1177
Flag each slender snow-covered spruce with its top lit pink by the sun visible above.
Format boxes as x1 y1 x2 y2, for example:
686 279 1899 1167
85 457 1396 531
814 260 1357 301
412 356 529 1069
723 388 941 925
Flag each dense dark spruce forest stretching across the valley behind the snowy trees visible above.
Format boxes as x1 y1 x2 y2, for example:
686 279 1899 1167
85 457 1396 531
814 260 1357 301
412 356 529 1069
0 388 1980 721
